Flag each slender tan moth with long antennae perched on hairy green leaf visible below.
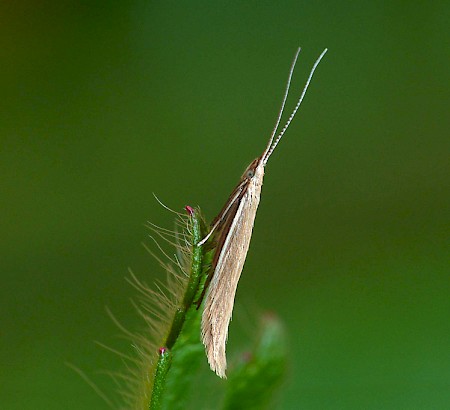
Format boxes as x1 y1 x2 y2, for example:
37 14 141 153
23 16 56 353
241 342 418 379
198 48 327 378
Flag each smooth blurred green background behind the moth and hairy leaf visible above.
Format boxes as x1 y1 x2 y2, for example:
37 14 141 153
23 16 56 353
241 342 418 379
0 1 450 410
